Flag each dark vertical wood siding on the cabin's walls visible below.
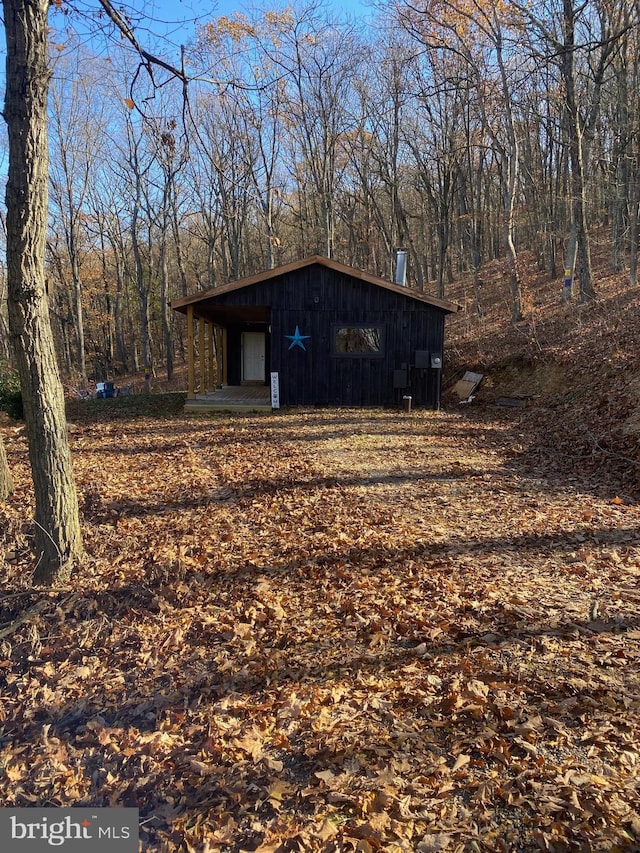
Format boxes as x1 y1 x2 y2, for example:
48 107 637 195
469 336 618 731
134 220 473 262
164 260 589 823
204 265 445 408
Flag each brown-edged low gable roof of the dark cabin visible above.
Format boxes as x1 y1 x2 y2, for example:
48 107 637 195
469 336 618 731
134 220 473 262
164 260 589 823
171 255 460 314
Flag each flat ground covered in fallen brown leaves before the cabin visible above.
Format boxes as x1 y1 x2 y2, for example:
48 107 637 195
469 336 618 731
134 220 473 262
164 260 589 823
0 398 640 853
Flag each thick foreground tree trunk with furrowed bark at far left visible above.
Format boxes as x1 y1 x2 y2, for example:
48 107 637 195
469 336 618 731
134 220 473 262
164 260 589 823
3 0 82 583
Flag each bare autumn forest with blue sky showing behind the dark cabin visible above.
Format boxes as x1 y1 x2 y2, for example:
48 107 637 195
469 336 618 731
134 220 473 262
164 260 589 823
5 0 640 385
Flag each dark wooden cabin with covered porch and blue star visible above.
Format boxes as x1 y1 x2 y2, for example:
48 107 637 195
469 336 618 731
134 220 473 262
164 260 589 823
172 256 458 409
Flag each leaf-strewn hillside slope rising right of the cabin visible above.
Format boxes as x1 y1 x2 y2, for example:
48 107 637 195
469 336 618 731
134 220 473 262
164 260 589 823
444 241 640 502
